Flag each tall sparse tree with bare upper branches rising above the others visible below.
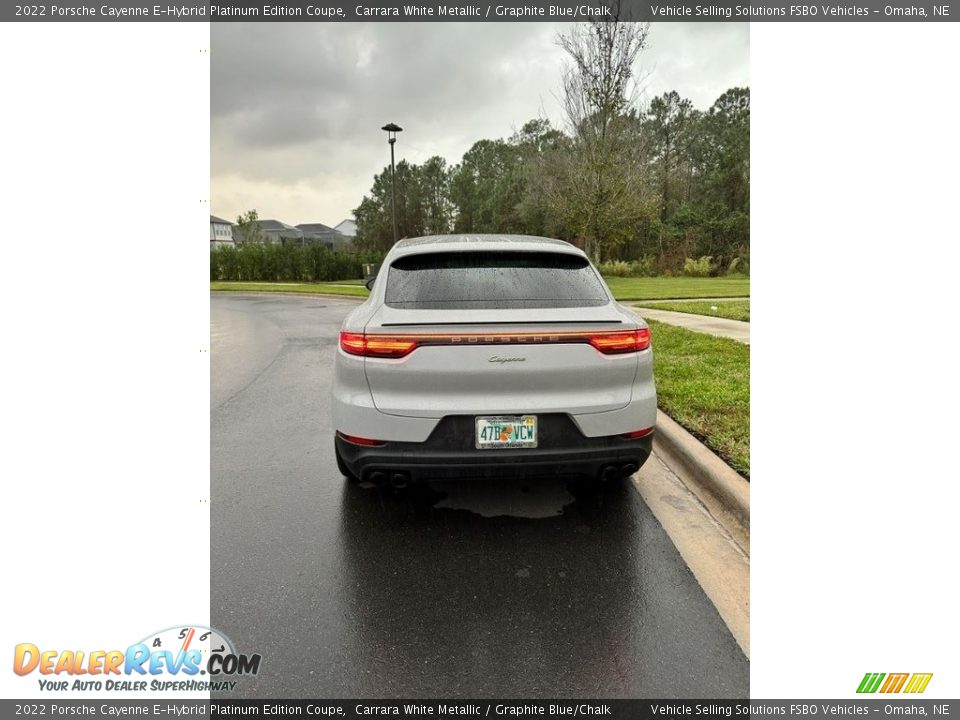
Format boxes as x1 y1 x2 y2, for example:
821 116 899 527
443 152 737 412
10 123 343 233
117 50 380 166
541 9 654 257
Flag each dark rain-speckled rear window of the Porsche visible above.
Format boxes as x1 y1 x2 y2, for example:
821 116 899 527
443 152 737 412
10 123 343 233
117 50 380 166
386 251 609 309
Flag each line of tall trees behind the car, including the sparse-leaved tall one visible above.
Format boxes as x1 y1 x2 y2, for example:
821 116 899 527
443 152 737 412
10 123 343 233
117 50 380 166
354 22 750 274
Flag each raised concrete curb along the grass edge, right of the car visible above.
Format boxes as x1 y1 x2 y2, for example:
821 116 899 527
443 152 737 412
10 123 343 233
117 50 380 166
653 410 750 533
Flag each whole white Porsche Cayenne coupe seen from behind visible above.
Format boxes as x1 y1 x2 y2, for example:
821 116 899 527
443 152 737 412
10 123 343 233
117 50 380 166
333 235 657 485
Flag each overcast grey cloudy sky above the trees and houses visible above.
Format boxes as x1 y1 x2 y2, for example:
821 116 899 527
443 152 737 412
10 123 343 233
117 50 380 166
211 22 750 226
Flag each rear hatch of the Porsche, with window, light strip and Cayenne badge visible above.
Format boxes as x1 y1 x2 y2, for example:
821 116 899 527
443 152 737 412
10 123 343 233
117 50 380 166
365 251 638 418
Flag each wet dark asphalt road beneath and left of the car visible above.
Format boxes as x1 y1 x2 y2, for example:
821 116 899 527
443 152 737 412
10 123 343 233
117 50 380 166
210 294 749 698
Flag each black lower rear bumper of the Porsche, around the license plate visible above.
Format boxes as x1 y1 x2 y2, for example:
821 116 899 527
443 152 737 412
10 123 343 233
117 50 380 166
335 415 653 481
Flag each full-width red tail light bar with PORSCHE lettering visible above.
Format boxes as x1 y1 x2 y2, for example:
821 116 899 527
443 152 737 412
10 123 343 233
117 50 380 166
340 328 650 358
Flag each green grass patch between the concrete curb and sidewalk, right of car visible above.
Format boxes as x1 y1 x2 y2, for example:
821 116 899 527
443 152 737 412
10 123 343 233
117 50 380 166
650 321 750 477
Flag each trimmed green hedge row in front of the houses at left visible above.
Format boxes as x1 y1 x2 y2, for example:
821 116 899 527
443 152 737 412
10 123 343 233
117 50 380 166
210 244 383 282
